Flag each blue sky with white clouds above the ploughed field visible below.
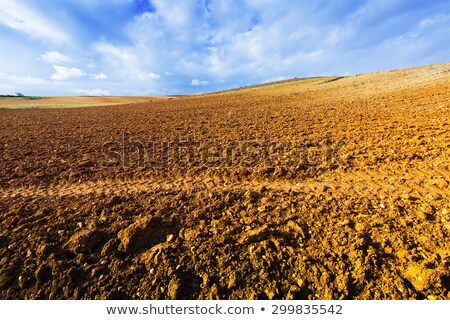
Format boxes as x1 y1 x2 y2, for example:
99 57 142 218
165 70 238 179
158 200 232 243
0 0 450 95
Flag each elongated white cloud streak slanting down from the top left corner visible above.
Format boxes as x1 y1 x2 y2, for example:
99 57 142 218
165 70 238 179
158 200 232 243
0 0 70 43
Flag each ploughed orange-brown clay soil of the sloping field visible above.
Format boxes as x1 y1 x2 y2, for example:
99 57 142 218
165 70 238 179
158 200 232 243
0 64 450 299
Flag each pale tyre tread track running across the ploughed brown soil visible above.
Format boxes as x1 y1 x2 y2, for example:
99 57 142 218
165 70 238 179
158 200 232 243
0 170 450 198
